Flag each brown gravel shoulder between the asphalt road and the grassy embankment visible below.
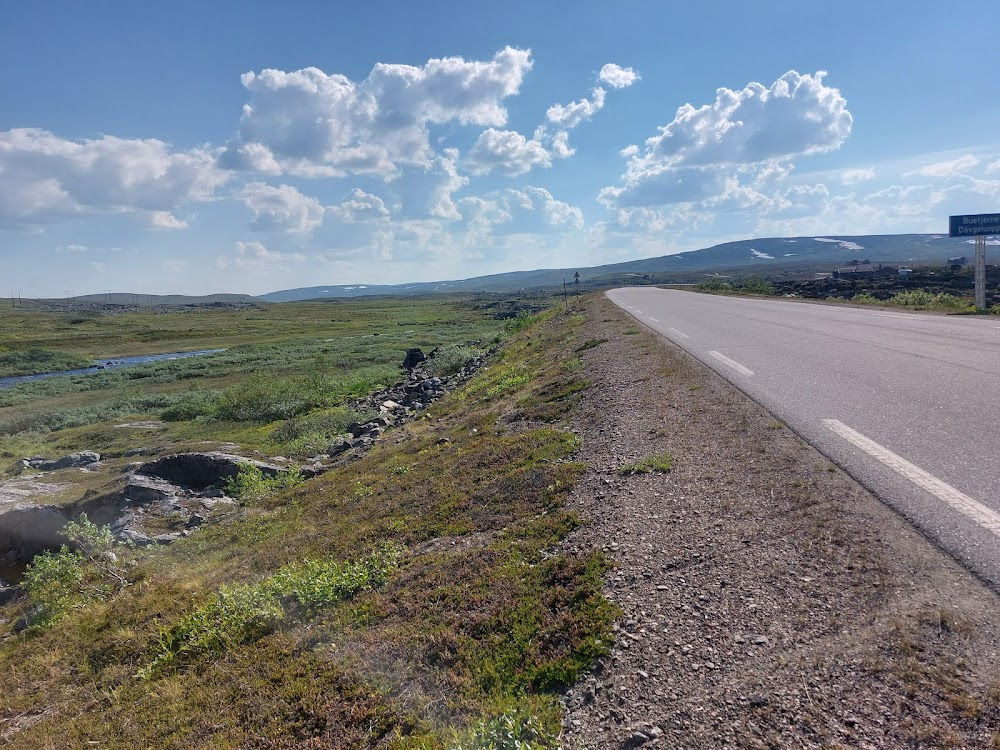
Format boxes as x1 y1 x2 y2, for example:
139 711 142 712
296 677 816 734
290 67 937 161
561 297 1000 748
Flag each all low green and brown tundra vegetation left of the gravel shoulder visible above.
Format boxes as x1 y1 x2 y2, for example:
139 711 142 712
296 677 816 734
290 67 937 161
0 297 616 750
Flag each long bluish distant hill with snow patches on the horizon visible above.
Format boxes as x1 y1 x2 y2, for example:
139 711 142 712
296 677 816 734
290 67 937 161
260 234 972 302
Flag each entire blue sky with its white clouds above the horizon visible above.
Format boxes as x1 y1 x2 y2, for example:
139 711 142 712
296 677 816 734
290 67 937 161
0 0 1000 297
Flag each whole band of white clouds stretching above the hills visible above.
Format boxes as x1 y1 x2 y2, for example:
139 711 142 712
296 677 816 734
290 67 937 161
11 40 1000 296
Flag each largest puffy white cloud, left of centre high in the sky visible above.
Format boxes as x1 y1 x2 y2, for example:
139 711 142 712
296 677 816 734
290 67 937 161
222 47 532 177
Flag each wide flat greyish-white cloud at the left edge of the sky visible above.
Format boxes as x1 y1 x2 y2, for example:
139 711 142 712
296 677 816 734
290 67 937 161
0 128 227 229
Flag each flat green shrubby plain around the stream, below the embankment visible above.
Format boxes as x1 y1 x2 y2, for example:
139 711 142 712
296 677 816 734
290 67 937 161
0 297 500 474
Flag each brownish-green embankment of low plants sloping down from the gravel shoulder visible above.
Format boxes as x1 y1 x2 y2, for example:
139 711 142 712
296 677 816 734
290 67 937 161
0 304 613 749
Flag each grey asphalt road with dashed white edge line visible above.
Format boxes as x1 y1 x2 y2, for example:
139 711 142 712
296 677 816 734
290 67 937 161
608 287 1000 590
